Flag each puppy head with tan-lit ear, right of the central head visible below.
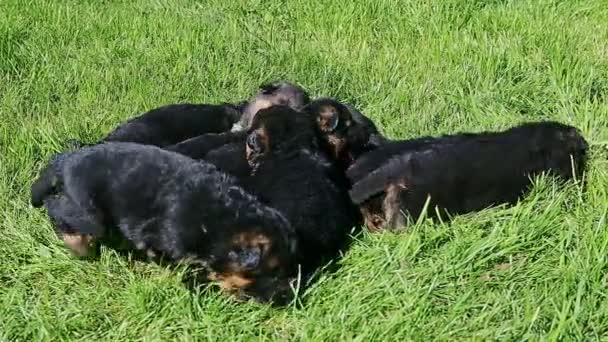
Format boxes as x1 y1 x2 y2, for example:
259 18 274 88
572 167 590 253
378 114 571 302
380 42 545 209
304 98 383 166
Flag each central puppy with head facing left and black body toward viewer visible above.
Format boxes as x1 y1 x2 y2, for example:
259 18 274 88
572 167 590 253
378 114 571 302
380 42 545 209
246 106 360 274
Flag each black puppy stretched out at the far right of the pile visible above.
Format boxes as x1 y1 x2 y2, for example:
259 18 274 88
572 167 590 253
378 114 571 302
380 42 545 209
347 122 588 230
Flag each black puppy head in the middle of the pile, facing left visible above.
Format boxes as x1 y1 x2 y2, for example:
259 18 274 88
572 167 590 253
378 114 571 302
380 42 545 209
246 106 318 167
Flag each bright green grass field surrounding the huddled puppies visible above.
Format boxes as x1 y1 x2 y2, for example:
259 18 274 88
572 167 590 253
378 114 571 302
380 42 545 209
0 0 608 341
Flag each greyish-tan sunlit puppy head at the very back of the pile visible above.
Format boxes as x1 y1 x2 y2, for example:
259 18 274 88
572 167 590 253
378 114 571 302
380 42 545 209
232 81 310 131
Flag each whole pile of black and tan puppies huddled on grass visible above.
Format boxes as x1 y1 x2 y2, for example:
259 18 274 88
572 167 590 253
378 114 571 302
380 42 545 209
31 82 588 304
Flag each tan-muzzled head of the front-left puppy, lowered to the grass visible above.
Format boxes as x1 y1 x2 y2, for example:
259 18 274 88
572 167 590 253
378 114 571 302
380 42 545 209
208 210 297 301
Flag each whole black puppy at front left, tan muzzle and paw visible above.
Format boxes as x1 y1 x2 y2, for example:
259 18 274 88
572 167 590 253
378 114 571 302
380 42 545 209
31 143 297 301
